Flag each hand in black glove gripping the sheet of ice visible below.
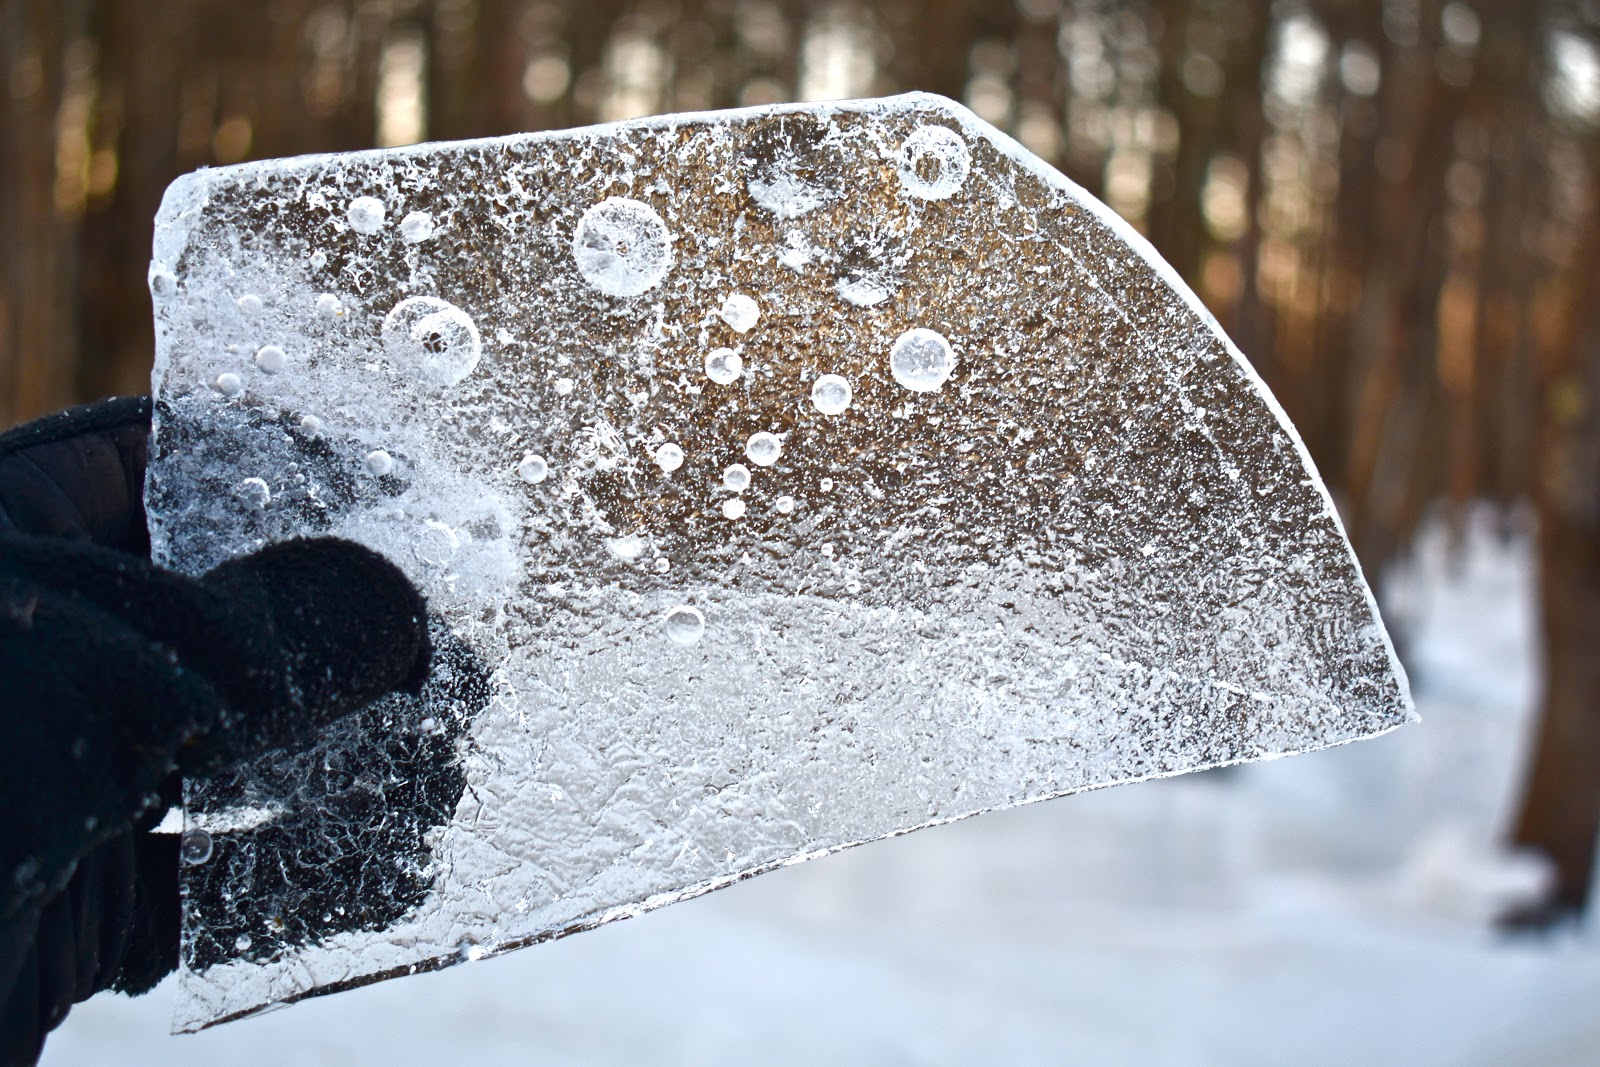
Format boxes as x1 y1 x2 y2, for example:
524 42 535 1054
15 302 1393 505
0 398 430 1064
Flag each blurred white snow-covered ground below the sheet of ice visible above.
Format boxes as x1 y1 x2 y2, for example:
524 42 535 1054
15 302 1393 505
45 515 1600 1067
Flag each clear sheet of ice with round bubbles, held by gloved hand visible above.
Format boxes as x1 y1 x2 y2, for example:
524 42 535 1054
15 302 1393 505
147 96 1408 1029
